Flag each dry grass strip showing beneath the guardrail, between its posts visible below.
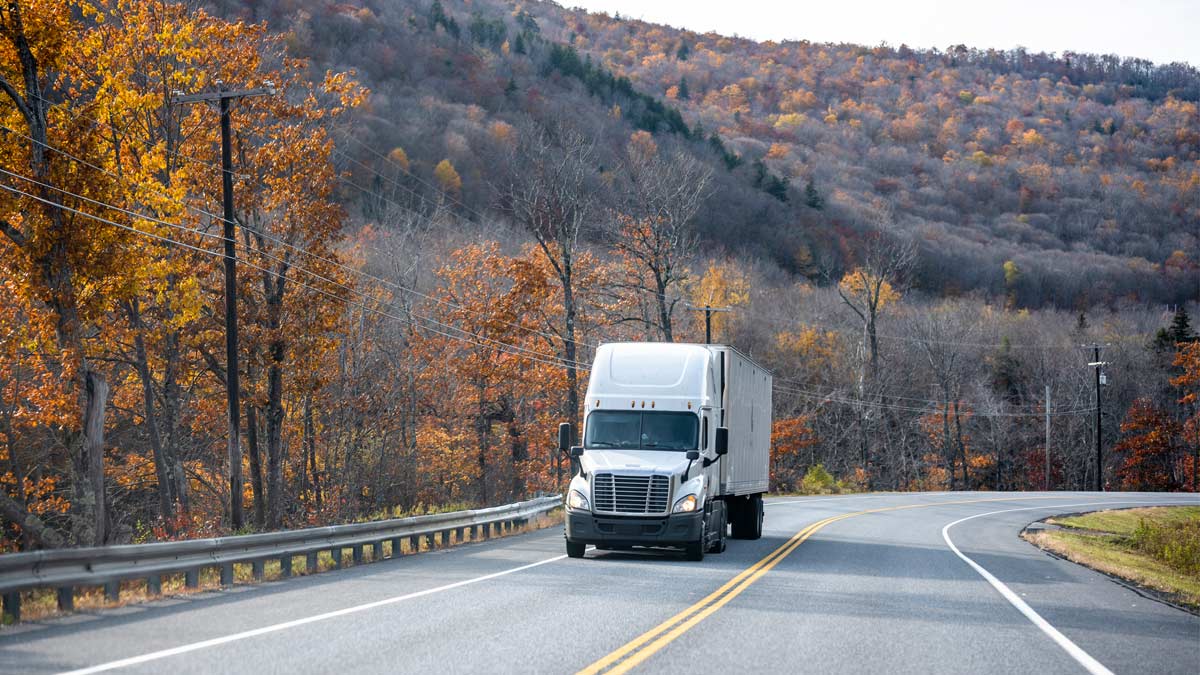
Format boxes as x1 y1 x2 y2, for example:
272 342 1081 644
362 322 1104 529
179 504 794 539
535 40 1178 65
4 510 563 625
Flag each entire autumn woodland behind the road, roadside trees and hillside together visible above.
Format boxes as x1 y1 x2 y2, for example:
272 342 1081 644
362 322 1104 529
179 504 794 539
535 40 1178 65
0 0 1200 550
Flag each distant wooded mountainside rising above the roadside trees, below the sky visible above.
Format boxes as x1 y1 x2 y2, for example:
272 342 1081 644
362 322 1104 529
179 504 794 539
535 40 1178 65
218 0 1200 302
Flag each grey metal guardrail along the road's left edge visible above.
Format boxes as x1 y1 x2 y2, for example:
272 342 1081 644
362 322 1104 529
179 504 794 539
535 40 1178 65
0 487 563 621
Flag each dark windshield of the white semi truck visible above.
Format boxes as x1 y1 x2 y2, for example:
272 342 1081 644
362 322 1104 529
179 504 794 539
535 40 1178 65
583 411 700 450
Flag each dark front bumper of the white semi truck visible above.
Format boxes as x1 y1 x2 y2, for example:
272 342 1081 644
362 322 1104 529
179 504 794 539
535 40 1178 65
566 510 704 546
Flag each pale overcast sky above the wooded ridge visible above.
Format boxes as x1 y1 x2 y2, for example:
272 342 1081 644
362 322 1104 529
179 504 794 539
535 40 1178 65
557 0 1200 66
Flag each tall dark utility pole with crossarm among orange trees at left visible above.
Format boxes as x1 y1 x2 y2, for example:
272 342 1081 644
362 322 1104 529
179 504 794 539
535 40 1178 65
172 80 275 530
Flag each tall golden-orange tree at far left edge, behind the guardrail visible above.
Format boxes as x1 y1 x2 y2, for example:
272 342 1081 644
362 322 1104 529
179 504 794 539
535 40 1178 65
0 1 136 545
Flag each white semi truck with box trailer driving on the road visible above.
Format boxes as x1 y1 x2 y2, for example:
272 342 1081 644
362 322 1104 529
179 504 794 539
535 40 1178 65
558 342 772 560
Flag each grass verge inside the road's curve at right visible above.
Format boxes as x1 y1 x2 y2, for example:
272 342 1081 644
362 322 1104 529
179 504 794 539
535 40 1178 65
1021 507 1200 613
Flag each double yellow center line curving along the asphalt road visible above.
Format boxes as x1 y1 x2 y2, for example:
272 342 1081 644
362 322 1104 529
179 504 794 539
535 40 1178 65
577 496 1068 675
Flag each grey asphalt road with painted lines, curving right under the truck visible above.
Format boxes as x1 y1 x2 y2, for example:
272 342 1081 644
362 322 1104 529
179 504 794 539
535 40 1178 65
0 492 1200 675
